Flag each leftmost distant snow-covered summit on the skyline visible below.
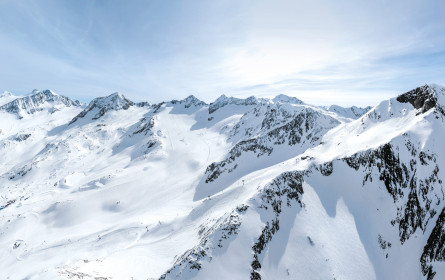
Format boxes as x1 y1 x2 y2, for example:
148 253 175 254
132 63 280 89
0 89 81 117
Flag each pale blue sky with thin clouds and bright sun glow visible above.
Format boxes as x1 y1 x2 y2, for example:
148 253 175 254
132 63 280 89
0 0 445 105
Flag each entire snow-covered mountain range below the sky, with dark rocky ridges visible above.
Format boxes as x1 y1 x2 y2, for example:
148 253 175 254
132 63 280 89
0 85 445 279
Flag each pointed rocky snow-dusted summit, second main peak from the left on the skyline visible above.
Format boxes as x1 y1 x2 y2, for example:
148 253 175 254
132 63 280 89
70 92 135 124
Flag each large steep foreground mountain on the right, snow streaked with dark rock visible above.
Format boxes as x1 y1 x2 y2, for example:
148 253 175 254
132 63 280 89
163 86 445 279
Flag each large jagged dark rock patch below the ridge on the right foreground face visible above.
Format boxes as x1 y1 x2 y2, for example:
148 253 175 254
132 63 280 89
343 143 441 247
